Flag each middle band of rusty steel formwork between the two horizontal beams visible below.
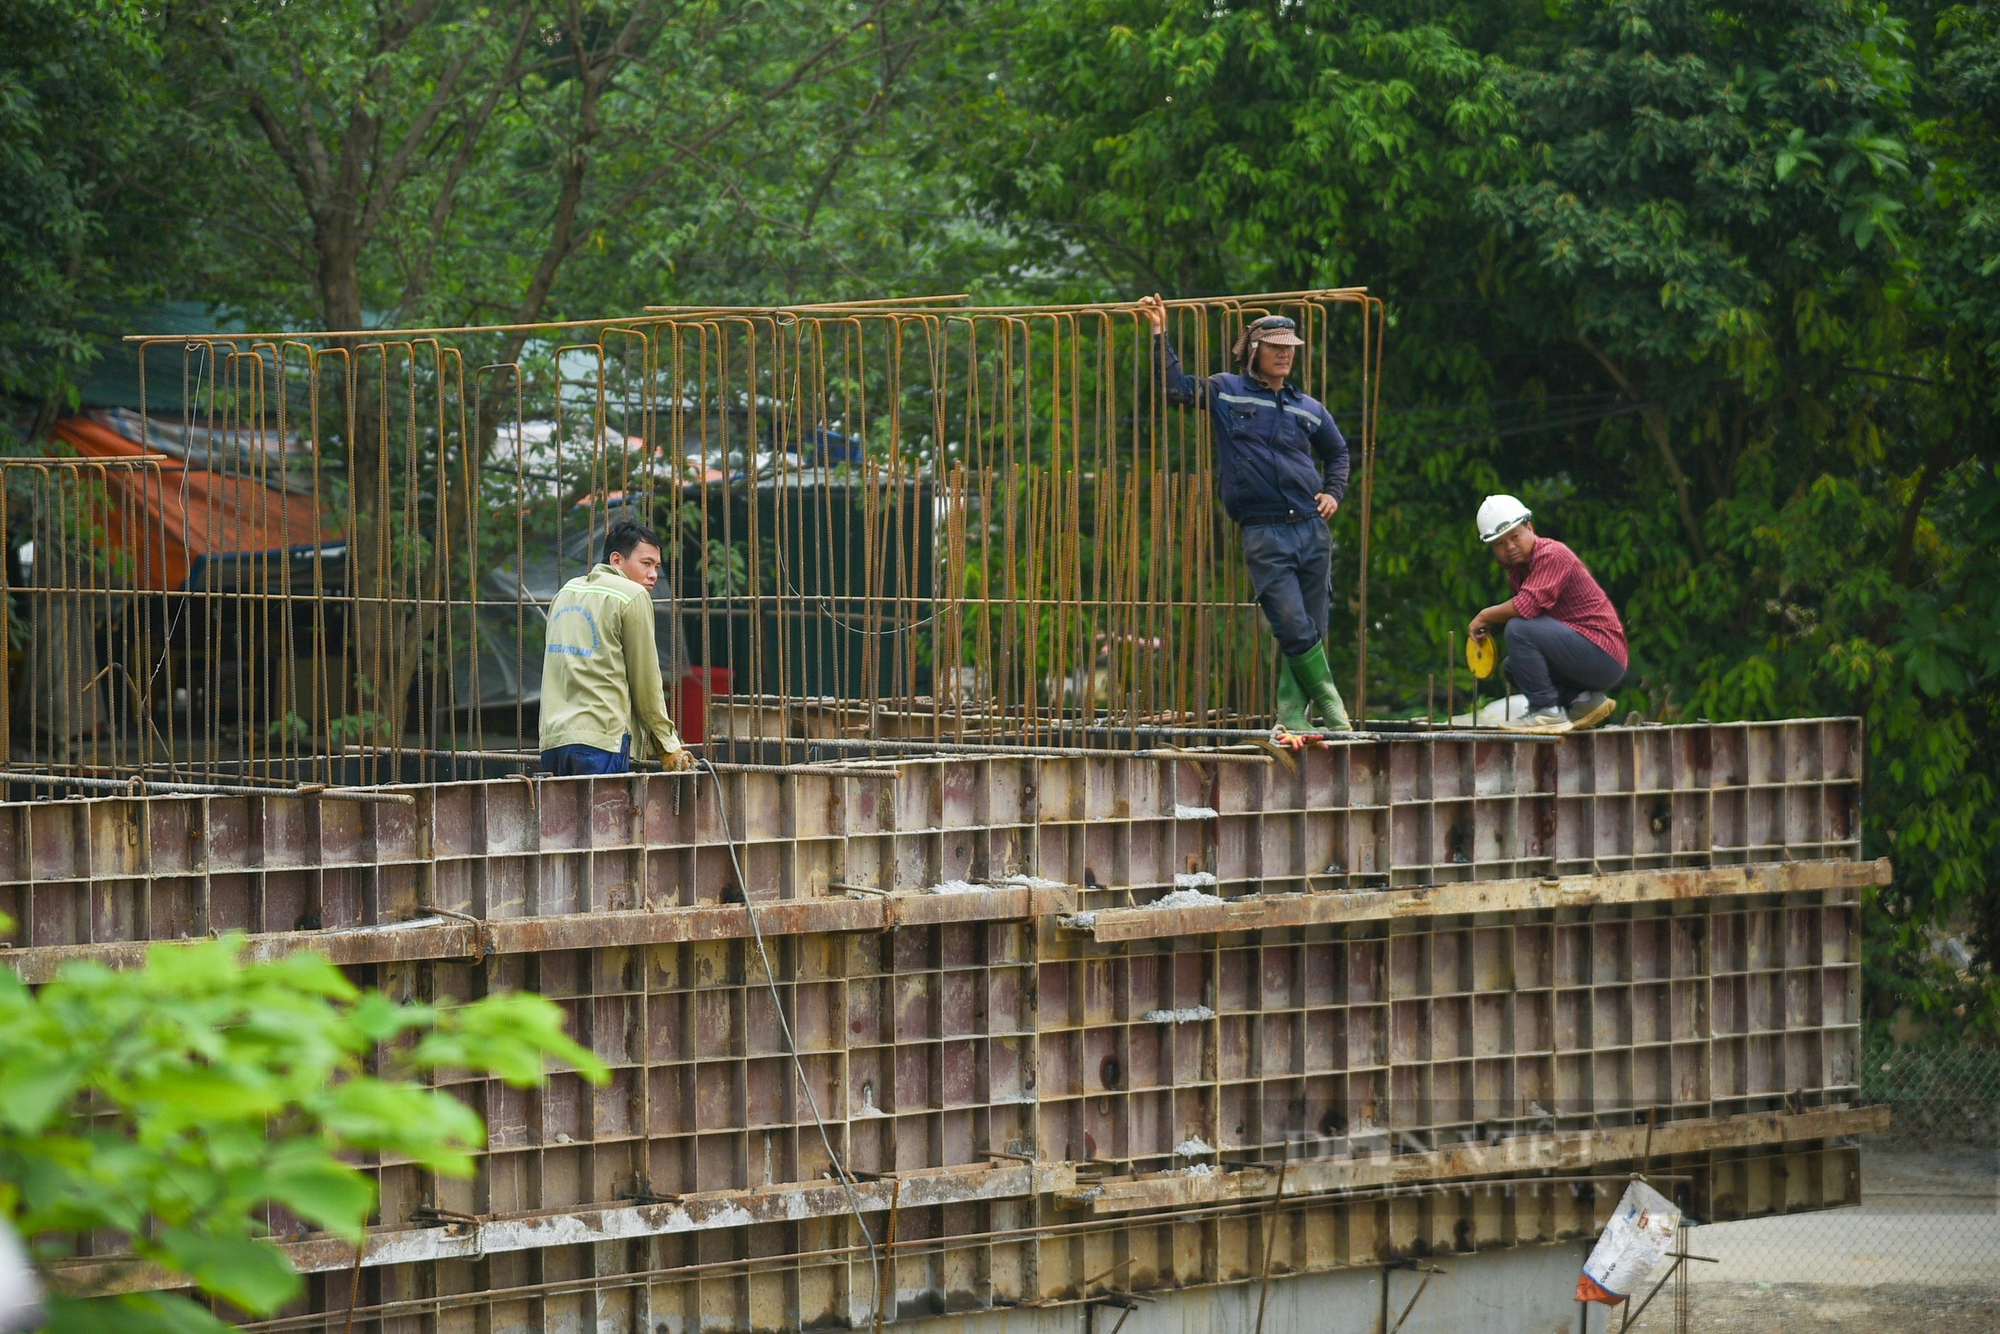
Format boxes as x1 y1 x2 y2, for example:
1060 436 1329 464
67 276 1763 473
262 890 1860 1216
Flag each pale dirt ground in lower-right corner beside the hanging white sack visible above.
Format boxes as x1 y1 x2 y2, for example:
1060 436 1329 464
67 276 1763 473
1610 1146 2000 1334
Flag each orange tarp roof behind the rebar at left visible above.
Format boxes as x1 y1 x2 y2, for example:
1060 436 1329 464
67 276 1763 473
56 416 340 590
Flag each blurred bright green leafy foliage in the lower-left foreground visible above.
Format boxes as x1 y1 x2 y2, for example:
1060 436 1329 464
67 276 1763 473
0 936 604 1334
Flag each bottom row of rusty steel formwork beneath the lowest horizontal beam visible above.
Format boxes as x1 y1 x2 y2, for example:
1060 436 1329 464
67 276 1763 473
133 1140 1860 1334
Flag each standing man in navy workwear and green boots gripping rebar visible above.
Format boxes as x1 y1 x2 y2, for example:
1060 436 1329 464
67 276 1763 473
1140 296 1354 736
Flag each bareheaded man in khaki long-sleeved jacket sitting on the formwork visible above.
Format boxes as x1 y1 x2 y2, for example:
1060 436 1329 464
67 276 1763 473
542 520 694 776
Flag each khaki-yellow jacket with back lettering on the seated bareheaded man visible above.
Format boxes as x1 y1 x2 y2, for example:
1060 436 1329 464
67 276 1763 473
542 564 680 760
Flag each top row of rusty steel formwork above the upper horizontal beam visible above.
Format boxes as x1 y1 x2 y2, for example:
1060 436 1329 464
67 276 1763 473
0 718 1860 964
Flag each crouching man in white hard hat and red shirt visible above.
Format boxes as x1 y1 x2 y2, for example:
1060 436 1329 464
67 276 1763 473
1466 496 1630 732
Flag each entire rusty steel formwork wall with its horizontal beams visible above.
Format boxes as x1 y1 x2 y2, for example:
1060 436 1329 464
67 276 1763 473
11 720 1886 1330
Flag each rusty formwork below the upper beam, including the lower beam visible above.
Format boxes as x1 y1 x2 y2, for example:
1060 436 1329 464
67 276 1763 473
113 888 1880 1330
